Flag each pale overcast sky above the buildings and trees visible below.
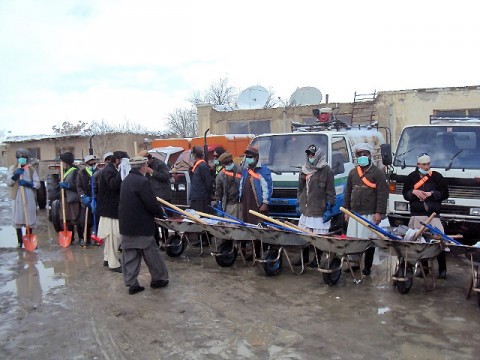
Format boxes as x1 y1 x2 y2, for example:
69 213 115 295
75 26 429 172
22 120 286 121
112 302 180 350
0 0 480 135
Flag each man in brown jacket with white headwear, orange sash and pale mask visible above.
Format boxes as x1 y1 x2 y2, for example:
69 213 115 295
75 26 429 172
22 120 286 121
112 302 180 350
343 143 388 276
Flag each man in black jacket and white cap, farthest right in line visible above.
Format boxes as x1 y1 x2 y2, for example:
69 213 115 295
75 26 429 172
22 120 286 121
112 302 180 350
403 154 449 279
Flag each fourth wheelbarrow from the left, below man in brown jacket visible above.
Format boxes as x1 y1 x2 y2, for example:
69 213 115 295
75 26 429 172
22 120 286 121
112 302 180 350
301 235 373 285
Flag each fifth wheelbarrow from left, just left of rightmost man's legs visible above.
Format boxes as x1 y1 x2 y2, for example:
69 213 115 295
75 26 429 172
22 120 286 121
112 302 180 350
372 238 442 294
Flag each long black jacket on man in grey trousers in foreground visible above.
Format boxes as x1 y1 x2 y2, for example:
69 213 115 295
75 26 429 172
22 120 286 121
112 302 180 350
118 169 163 236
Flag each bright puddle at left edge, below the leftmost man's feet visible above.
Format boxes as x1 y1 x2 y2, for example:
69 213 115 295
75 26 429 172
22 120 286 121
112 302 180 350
0 252 65 304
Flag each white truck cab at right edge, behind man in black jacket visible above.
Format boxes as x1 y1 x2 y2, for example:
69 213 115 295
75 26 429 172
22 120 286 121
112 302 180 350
388 118 480 240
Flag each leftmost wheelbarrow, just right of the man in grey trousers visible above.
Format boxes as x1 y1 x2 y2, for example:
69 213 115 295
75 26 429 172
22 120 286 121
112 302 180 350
155 218 211 257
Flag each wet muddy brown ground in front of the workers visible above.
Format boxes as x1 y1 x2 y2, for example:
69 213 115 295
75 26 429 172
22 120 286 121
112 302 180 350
0 174 480 360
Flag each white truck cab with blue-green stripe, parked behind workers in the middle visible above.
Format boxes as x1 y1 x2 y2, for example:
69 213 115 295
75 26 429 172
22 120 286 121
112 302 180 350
252 122 385 231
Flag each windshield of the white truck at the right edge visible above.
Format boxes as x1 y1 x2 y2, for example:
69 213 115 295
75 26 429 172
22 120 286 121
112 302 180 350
393 126 480 169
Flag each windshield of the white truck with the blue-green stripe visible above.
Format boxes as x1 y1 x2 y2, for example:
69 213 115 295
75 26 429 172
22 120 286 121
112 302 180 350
252 133 328 172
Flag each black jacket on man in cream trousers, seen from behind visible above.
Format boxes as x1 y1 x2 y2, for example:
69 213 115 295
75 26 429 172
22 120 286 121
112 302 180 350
97 162 122 219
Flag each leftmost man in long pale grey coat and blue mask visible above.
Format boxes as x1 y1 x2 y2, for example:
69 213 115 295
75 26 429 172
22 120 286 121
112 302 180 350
6 148 40 248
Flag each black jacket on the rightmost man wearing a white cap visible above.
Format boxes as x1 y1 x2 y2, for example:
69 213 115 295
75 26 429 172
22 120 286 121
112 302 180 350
403 170 449 216
